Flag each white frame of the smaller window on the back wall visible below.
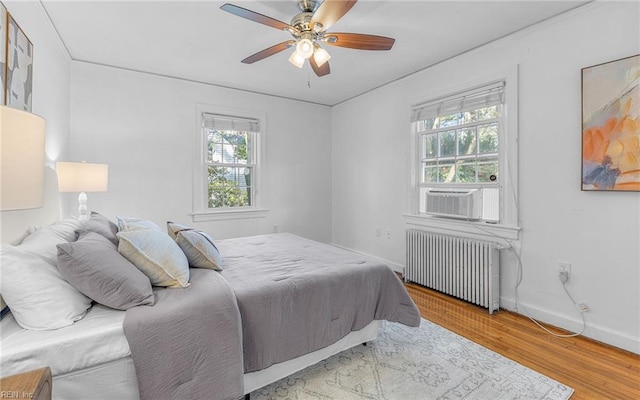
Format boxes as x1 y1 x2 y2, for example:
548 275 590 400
191 104 267 222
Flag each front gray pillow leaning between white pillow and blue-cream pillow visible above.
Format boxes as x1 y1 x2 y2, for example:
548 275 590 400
58 232 155 310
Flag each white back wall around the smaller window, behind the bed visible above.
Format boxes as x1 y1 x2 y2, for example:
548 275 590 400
71 62 331 242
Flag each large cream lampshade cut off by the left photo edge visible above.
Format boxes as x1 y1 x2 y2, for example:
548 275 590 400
0 106 45 211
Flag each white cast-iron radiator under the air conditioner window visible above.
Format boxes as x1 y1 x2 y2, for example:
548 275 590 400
405 229 500 314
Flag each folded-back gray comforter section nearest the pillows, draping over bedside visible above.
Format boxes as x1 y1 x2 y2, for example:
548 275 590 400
124 268 244 400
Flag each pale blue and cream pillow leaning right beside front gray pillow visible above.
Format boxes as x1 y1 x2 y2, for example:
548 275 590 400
118 229 189 287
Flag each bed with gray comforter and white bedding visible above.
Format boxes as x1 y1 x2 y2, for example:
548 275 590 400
0 214 420 399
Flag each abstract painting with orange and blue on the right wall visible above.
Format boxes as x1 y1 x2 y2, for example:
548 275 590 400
582 54 640 191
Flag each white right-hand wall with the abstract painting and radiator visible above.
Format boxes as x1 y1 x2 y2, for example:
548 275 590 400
332 2 640 353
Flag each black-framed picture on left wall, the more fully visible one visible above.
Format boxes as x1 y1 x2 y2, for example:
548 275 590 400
5 13 33 112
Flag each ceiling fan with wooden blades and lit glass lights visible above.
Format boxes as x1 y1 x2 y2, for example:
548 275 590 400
220 0 395 76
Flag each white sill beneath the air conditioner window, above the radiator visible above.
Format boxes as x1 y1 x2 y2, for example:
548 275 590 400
403 214 520 245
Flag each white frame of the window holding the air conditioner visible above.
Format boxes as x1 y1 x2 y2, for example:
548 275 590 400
404 65 520 241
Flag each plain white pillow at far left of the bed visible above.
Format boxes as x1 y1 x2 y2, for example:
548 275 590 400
0 245 91 330
